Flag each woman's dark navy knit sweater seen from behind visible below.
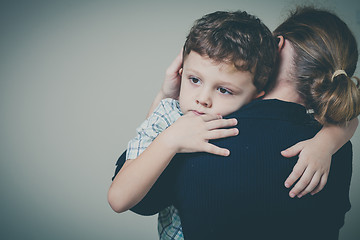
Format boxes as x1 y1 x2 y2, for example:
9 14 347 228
115 100 352 240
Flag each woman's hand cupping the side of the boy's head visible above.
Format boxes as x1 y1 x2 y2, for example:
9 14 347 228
161 50 182 99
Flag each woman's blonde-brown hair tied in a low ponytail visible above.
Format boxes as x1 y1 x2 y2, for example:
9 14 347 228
274 7 360 124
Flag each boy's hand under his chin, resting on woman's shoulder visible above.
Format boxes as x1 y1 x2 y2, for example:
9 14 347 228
163 112 239 156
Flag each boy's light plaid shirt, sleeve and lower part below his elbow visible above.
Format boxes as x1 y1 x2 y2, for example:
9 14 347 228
126 98 184 240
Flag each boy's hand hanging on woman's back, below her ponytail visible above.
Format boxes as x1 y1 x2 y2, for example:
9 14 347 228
281 139 332 198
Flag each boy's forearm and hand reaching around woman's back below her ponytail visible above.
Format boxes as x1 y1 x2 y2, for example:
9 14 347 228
281 118 359 198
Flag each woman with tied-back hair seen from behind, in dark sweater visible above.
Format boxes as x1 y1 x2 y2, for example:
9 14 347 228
111 8 360 239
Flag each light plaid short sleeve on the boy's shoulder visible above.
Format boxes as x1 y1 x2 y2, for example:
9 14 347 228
126 99 180 159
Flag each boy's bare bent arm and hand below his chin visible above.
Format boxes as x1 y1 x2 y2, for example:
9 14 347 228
108 112 238 212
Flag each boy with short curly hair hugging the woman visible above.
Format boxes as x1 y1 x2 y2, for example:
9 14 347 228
109 9 356 239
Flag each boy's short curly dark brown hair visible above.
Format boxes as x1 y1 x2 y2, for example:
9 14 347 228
183 11 277 92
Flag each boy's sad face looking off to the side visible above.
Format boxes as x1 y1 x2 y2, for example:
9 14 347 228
179 51 257 116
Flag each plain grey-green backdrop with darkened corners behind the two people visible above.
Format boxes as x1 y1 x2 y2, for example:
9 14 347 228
0 0 360 240
